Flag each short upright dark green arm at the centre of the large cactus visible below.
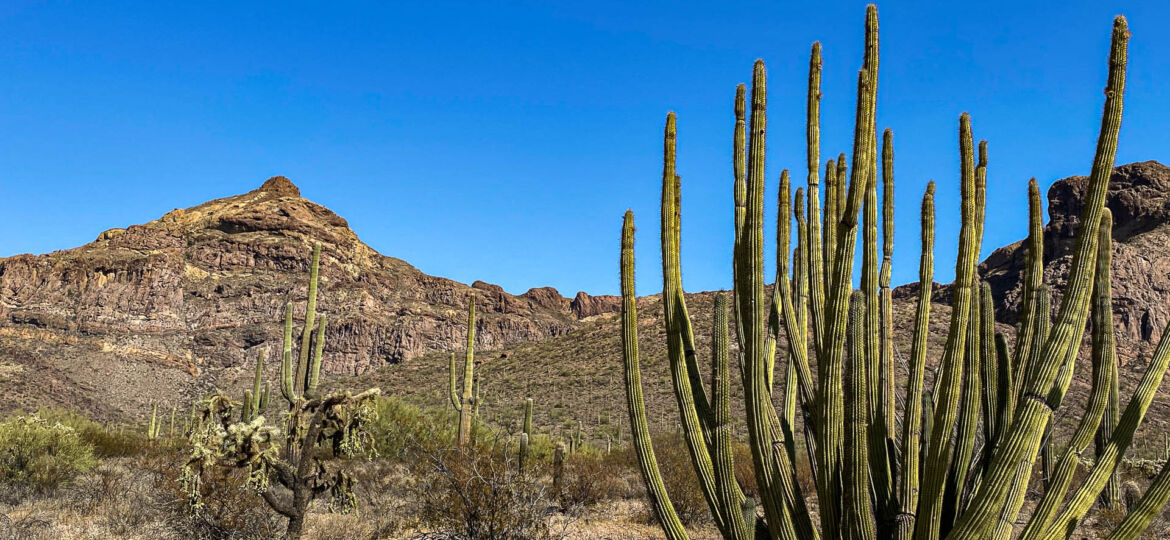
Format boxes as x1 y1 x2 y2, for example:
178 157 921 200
841 291 878 540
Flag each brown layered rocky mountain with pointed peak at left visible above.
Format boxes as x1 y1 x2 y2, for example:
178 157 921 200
0 176 617 414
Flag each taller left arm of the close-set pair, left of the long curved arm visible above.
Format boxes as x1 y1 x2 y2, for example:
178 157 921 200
915 112 978 540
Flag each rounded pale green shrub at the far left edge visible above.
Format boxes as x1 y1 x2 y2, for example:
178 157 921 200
0 415 96 492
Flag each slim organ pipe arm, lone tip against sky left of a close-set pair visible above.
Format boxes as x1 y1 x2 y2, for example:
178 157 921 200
894 181 935 540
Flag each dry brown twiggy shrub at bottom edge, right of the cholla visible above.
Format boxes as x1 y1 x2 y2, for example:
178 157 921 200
413 445 563 540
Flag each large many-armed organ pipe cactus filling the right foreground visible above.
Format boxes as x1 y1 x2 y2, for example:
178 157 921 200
621 6 1170 540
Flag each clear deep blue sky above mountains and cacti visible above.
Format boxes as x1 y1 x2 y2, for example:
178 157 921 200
0 0 1170 296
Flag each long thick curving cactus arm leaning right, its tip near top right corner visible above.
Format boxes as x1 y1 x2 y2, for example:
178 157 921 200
954 16 1129 540
